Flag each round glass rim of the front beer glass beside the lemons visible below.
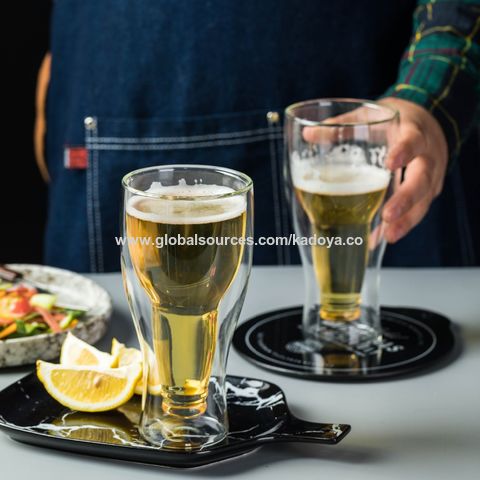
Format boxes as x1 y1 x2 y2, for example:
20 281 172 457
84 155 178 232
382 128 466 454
122 163 253 201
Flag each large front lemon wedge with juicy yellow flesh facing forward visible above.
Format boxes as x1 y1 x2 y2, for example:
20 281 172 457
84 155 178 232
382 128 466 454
37 360 142 412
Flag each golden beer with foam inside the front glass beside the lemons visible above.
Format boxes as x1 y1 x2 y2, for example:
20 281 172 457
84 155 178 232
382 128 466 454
126 184 246 413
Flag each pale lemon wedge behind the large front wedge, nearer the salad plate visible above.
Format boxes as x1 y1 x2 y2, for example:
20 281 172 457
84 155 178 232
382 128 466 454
60 332 116 368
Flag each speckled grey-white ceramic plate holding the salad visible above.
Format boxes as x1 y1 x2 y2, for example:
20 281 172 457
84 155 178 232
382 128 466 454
0 264 112 367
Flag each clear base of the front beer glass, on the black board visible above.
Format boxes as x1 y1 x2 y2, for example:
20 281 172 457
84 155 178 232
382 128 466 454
139 414 227 451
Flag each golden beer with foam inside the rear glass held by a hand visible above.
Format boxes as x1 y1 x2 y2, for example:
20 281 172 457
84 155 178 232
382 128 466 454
294 165 390 321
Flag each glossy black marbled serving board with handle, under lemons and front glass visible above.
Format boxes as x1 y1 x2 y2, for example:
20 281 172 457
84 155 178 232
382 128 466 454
0 373 350 468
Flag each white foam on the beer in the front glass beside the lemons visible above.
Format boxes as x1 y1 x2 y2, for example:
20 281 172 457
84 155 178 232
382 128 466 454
127 179 246 225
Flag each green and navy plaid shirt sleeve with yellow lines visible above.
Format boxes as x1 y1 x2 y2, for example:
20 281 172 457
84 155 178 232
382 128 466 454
384 0 480 158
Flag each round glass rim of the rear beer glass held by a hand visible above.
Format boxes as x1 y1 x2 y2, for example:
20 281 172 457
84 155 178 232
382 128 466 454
285 97 400 128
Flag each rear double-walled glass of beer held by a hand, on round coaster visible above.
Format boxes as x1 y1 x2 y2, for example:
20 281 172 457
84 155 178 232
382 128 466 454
285 99 398 350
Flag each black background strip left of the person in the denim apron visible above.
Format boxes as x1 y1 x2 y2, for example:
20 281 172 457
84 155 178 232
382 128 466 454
0 0 51 263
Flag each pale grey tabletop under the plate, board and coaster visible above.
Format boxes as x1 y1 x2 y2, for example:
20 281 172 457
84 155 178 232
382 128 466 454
0 267 480 480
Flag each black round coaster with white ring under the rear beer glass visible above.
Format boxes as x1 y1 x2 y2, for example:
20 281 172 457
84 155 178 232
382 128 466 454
233 307 460 381
